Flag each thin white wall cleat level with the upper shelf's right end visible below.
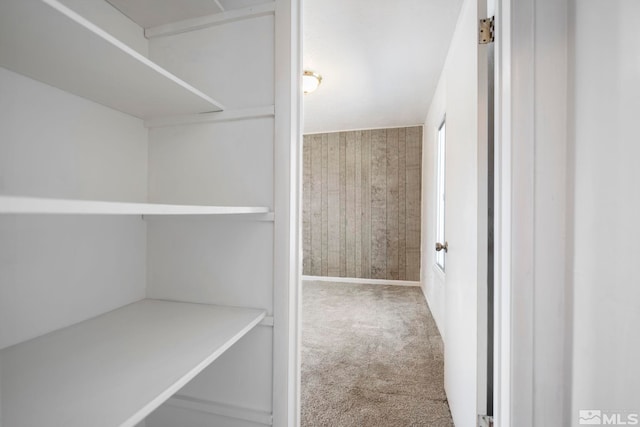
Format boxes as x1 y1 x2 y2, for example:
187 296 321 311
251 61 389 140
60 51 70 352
144 105 275 128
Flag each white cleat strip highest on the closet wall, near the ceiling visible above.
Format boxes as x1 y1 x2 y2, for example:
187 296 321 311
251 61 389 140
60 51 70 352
144 2 276 39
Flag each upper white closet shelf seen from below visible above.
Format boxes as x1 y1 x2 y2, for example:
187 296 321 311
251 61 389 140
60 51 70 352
0 0 223 120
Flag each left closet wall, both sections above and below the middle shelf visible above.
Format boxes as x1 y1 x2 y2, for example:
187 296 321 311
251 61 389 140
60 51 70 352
0 68 147 348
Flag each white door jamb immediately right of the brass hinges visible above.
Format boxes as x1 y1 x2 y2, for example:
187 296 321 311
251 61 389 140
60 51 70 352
494 0 535 427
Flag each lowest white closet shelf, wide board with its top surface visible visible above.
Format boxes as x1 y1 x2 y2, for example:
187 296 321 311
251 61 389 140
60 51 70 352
0 300 265 427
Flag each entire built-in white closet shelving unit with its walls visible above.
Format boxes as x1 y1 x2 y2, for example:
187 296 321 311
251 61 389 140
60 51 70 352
0 0 296 427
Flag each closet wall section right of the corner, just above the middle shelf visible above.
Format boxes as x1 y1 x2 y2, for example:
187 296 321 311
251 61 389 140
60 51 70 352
149 117 274 208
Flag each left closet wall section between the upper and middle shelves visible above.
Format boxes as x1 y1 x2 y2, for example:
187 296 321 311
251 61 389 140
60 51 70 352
0 68 147 202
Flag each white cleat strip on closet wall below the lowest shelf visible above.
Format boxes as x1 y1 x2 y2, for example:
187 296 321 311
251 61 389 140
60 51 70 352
165 395 273 426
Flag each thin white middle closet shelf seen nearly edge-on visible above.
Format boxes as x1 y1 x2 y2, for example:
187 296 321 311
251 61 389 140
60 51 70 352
0 196 269 215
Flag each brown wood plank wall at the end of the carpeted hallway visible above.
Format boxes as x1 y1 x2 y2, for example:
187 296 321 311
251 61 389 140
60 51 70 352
303 126 422 281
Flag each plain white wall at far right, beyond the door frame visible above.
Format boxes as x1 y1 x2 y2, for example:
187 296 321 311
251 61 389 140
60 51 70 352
570 0 640 425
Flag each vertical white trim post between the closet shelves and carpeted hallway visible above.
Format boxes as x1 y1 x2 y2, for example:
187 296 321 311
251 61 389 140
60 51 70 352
272 0 302 427
